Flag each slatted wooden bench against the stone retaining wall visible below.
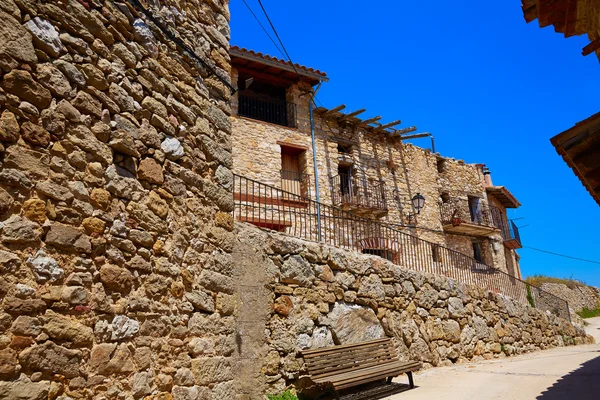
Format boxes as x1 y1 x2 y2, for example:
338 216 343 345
302 338 422 399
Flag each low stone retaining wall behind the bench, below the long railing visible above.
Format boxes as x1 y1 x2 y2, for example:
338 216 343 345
234 223 593 393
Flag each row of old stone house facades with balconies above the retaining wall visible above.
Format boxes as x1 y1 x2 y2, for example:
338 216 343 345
230 47 521 278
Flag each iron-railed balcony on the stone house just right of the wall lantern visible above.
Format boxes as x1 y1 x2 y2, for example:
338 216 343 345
440 199 504 236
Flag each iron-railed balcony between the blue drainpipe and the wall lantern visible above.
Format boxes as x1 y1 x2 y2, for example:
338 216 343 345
331 174 388 216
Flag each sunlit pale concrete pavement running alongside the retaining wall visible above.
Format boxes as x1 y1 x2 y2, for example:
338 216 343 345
388 317 600 400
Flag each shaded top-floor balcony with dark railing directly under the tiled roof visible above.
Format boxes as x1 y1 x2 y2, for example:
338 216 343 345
238 93 297 128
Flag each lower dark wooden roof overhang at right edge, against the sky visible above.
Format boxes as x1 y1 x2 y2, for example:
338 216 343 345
550 113 600 205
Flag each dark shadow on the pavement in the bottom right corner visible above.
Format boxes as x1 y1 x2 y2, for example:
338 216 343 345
536 351 600 400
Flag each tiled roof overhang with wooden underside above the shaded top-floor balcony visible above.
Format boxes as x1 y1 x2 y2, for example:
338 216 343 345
229 46 329 86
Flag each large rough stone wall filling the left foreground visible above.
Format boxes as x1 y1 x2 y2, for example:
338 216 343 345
0 0 235 399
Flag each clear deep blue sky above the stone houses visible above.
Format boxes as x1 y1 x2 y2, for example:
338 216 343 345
230 0 600 286
